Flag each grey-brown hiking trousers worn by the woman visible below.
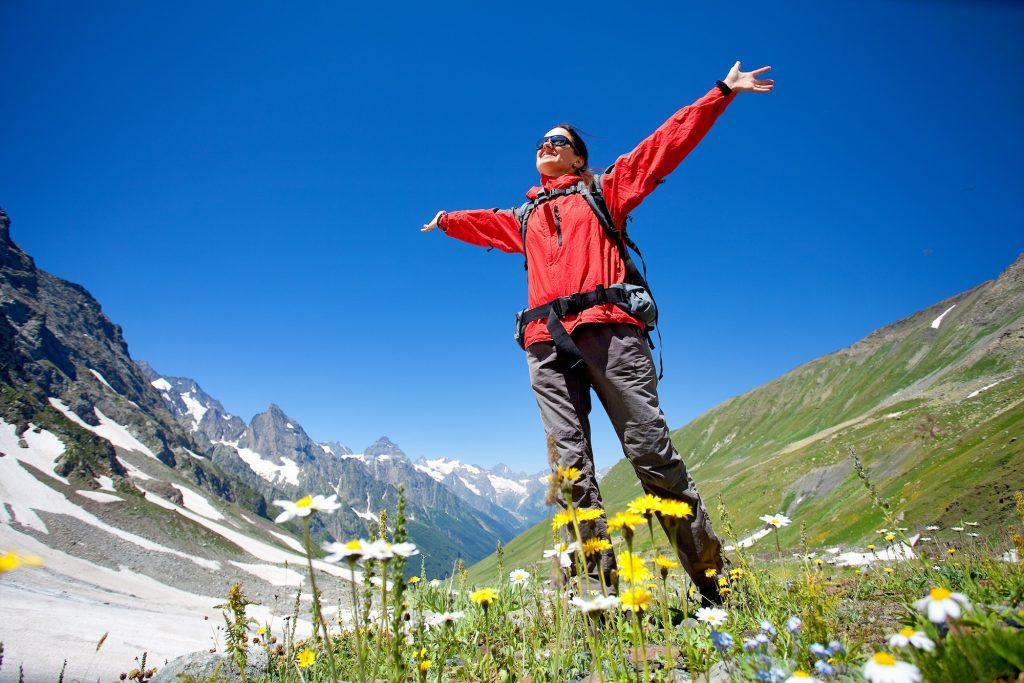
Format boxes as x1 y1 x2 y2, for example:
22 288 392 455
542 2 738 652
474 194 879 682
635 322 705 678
526 324 722 597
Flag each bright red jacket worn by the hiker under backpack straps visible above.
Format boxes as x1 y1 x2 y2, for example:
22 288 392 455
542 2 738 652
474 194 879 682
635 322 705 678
439 86 736 346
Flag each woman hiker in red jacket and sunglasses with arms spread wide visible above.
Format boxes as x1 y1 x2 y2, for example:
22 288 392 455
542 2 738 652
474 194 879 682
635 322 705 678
422 61 774 604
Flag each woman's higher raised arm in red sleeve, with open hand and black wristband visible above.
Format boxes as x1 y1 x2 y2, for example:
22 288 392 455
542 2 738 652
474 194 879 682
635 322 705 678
602 61 775 224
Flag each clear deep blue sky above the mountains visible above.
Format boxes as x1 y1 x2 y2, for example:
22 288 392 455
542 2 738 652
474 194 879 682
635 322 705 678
0 1 1024 470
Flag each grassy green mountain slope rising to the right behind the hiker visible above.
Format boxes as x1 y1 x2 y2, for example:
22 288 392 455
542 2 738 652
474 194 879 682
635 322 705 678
470 256 1024 581
